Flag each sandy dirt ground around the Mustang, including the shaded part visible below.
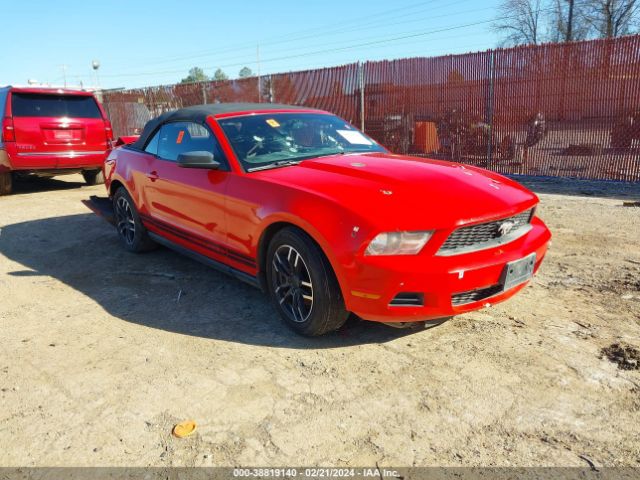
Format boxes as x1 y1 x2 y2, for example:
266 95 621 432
0 176 640 467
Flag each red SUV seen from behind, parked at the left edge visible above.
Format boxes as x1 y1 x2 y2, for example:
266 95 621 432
0 86 113 195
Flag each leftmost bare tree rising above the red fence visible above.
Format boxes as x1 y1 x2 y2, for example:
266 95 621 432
493 0 544 45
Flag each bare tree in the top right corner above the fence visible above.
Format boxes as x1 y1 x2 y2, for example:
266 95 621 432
586 0 640 38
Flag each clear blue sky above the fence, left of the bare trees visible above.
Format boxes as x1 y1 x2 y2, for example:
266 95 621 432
0 0 498 88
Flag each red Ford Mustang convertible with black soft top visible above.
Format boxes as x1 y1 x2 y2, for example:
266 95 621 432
104 104 551 335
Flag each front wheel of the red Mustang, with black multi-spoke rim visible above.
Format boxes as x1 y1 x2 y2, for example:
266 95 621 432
266 227 349 336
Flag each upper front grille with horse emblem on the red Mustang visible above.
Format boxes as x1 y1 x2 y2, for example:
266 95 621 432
438 209 533 255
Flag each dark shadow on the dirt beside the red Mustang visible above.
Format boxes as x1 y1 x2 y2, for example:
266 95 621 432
0 213 430 349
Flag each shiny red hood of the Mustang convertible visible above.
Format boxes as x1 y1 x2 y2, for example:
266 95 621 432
251 153 538 229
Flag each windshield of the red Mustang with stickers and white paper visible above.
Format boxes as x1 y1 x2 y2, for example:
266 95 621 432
219 113 385 171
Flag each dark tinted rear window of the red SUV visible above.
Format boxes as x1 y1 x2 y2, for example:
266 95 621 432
11 93 102 118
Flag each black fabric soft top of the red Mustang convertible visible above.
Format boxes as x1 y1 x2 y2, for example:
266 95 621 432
129 103 315 150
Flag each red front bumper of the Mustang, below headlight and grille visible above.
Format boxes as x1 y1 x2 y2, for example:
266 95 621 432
343 218 551 322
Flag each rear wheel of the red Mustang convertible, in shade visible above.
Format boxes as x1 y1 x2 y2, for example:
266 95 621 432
113 187 156 253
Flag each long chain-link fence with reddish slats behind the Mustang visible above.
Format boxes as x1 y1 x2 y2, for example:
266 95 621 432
103 35 640 181
